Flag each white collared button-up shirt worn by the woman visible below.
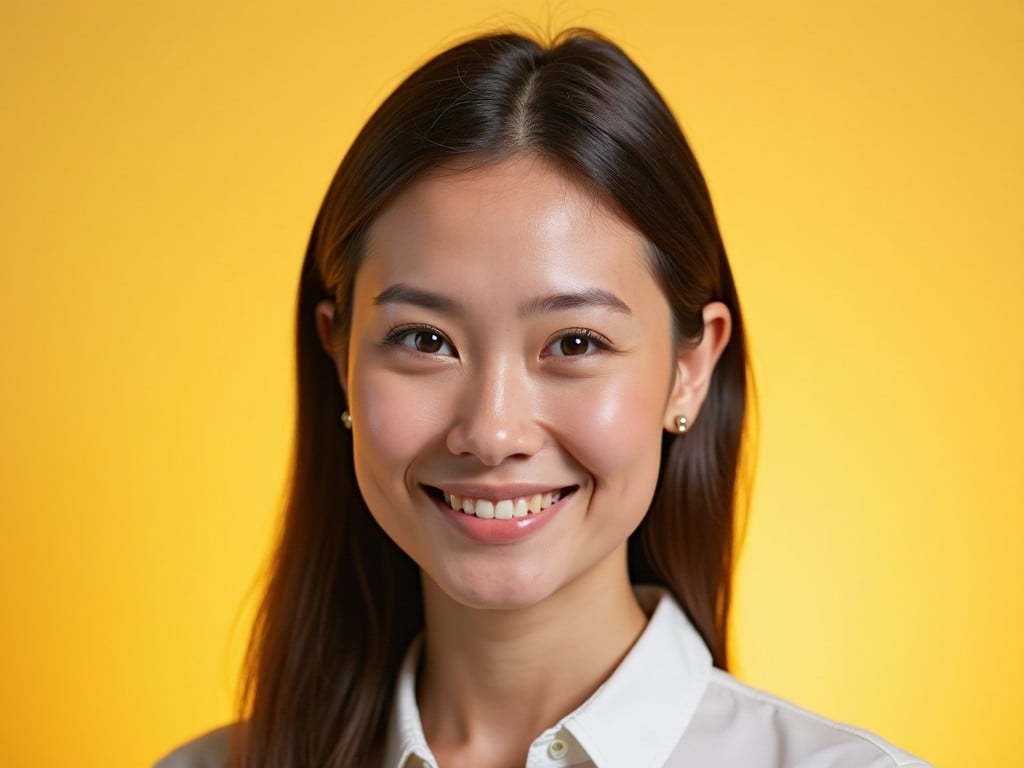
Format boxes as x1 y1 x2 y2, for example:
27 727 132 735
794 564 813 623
382 587 928 768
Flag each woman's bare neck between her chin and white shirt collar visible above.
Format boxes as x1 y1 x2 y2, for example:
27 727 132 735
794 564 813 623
418 547 647 766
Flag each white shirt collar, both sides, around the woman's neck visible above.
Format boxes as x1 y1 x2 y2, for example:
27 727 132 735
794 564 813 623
384 587 712 768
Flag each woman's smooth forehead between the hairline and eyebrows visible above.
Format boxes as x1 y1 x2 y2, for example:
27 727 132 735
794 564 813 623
356 158 660 311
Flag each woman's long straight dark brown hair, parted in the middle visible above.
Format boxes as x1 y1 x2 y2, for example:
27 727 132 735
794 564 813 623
232 31 748 768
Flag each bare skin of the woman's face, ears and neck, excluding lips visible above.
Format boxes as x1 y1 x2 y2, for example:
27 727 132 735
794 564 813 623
317 158 729 768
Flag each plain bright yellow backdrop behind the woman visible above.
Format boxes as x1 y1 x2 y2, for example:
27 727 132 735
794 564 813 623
0 0 1024 768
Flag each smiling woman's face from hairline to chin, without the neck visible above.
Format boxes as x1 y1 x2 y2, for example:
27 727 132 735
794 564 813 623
322 159 708 608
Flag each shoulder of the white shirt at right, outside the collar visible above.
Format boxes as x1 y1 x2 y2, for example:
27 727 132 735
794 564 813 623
681 669 928 768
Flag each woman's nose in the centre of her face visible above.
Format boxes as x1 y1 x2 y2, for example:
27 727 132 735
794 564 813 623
445 364 544 467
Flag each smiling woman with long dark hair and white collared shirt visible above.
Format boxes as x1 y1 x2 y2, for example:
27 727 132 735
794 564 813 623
155 27 924 768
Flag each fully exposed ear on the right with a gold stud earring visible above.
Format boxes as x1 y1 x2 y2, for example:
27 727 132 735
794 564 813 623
663 301 732 432
